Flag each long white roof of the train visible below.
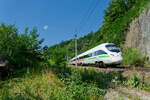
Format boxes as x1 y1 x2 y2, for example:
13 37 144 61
71 43 113 60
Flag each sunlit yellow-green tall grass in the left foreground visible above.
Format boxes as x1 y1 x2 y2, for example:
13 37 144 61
0 69 105 100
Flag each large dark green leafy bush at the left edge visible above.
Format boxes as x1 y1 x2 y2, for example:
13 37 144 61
0 24 43 71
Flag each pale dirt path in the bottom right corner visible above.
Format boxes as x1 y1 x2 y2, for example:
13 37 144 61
104 87 150 100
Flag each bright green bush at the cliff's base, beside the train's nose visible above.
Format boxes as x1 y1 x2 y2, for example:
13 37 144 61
123 48 148 66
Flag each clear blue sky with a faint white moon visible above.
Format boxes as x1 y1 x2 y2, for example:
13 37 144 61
0 0 110 46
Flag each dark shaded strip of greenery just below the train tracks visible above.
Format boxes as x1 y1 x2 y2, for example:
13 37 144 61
51 66 126 89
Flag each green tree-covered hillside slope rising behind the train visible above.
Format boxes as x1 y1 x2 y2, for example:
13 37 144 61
49 0 148 58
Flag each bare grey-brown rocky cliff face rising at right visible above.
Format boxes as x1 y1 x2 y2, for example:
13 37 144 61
125 2 150 58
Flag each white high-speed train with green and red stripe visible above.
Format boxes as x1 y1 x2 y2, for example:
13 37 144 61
69 43 123 67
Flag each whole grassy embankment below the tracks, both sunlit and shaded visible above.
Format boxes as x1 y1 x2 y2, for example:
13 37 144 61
0 66 150 100
